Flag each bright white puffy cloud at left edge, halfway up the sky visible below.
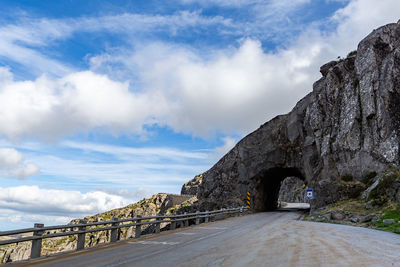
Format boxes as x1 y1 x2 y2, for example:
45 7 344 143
0 71 157 139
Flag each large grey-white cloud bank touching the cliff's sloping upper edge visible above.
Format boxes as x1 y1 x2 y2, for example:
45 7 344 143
90 0 400 137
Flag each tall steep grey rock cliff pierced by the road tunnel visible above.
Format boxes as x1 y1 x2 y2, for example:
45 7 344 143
183 23 400 210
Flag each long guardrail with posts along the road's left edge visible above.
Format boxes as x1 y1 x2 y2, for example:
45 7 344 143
0 207 248 259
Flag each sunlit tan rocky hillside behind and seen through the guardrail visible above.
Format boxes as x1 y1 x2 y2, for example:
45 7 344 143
0 193 197 263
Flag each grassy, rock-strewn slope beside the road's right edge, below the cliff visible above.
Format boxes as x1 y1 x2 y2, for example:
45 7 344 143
306 169 400 234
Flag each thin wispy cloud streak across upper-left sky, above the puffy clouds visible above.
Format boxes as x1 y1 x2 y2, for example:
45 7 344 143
0 11 232 76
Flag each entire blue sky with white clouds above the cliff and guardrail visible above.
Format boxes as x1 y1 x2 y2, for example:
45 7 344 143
0 0 400 231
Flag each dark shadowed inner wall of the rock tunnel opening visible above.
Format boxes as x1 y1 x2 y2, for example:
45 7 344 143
254 168 305 211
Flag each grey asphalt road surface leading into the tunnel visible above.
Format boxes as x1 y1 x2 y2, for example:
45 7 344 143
11 212 400 267
